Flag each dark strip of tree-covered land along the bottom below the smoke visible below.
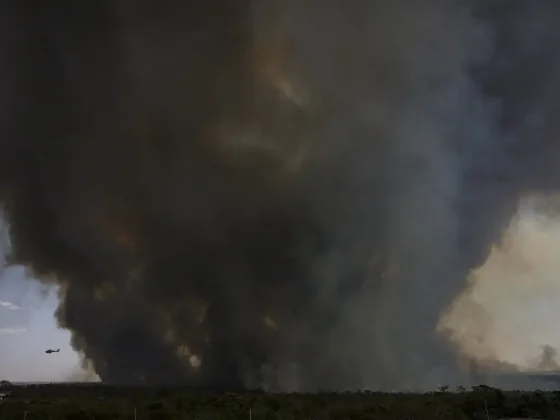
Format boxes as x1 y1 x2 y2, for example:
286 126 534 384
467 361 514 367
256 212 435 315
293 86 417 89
0 385 560 420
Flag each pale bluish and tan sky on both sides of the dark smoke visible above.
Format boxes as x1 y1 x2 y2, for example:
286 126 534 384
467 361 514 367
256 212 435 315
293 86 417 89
0 197 560 382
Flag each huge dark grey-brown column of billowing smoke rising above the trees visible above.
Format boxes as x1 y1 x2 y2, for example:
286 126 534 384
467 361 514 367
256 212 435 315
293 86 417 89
0 0 560 390
